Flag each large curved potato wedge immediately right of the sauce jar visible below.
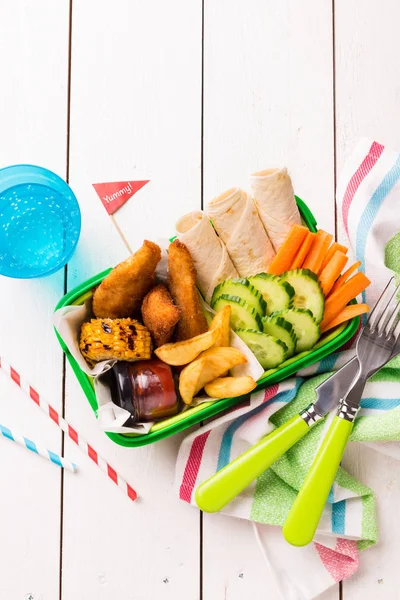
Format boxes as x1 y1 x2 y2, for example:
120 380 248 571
179 348 247 404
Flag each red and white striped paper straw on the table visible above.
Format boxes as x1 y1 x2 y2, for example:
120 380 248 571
0 357 137 500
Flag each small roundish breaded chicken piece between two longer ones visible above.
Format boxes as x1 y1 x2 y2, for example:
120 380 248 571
142 285 182 348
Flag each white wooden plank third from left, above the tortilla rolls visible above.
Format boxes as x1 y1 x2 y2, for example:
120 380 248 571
203 0 338 600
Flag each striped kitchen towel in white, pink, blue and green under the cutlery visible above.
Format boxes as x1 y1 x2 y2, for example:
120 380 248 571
176 140 400 600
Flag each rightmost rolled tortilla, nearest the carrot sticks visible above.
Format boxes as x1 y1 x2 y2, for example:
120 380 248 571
250 169 301 252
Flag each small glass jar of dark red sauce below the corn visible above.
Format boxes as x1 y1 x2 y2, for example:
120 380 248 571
112 359 179 425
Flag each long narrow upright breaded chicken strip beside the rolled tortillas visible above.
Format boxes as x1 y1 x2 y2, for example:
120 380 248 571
168 240 208 340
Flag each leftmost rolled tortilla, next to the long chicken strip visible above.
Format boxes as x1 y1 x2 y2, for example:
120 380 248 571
176 210 238 302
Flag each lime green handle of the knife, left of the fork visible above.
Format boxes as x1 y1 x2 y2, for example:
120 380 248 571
195 415 310 512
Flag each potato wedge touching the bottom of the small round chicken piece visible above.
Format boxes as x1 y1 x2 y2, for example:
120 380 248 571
154 328 219 367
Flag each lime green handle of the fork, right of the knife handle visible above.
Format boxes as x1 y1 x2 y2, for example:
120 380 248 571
283 416 353 546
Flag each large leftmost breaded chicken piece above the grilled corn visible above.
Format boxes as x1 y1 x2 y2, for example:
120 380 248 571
93 240 161 319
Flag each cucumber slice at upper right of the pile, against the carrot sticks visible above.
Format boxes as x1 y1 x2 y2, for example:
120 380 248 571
282 269 325 323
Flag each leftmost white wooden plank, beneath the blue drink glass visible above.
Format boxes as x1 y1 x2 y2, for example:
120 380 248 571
0 0 69 600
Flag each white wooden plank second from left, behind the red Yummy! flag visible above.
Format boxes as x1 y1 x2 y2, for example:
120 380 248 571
62 0 201 600
